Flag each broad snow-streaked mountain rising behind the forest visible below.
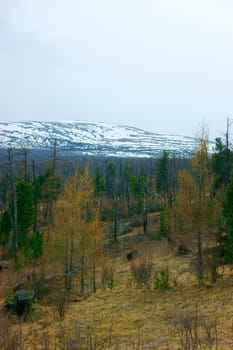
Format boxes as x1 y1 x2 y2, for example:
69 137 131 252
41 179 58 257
0 121 200 158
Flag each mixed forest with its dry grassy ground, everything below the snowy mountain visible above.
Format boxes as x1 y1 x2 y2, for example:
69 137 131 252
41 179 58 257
0 130 233 350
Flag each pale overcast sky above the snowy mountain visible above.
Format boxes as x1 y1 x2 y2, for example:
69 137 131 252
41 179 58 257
0 0 233 138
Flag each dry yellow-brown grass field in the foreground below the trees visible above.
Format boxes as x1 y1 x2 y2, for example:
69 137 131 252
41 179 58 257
0 232 233 350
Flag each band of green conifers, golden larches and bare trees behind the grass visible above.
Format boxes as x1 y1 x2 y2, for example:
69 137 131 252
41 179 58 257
0 130 233 291
